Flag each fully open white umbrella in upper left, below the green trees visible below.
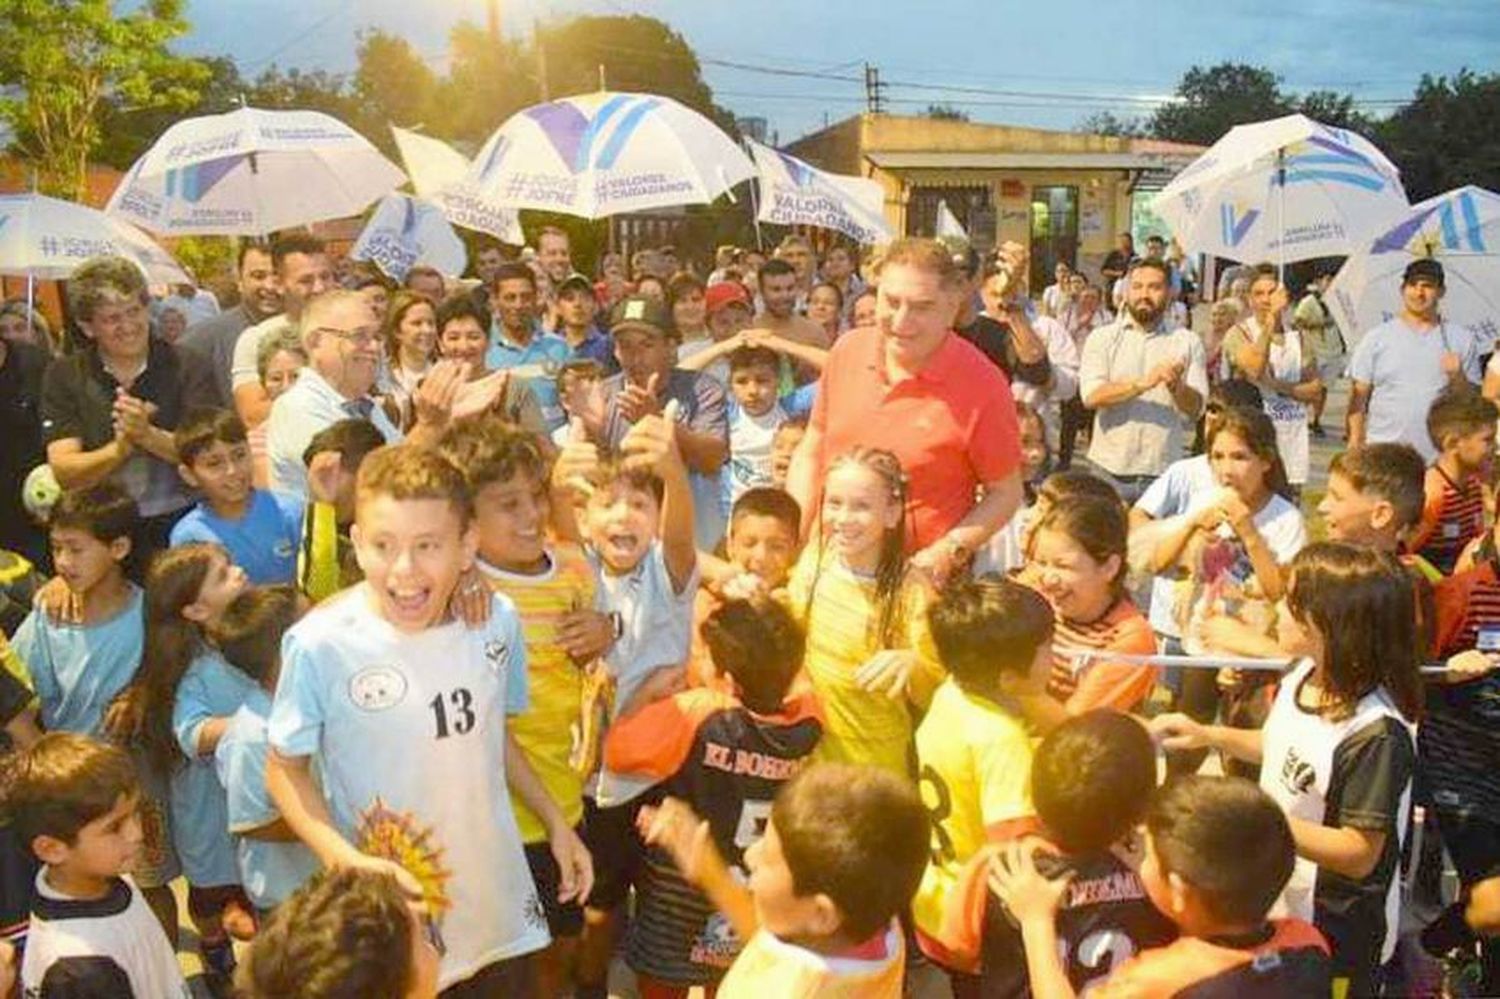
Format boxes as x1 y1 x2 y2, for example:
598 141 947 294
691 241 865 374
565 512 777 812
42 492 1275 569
105 108 407 236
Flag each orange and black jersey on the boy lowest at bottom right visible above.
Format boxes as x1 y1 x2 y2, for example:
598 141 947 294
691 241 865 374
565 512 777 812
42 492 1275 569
1089 920 1332 999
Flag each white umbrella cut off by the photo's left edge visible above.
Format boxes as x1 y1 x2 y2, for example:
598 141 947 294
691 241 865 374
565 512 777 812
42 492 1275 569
0 194 189 284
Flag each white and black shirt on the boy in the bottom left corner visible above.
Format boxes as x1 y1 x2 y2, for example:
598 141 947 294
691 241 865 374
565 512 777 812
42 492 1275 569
21 867 192 999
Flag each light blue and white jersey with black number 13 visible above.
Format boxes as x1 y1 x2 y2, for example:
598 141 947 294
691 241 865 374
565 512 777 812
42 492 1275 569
269 584 551 989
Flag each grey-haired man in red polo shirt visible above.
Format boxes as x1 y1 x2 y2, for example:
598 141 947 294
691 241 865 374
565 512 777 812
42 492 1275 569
788 239 1022 581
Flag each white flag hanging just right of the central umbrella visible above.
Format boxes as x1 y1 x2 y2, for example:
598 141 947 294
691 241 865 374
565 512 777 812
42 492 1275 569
747 140 894 243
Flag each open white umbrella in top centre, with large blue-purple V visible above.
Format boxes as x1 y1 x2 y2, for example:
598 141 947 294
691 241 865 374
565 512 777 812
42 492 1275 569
468 92 755 219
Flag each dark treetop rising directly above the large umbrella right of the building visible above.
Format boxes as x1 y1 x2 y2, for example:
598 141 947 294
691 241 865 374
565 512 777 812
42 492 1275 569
1151 63 1293 146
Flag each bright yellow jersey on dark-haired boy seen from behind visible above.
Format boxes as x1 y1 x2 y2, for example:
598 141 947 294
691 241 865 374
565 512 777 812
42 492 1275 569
912 680 1034 959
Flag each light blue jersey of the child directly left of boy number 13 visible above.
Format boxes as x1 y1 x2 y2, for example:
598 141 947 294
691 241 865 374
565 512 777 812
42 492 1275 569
213 687 320 909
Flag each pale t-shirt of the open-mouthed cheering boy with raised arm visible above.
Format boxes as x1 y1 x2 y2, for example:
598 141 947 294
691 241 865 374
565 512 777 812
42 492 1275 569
584 542 698 807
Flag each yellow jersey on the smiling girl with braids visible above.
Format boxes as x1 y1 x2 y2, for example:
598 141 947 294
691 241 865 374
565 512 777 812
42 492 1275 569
788 546 944 777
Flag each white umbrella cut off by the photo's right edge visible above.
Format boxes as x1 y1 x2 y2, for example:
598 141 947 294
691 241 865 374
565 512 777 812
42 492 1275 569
1328 186 1500 344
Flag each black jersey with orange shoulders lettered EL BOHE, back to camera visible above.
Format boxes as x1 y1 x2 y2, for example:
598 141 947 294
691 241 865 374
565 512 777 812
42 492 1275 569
605 687 824 986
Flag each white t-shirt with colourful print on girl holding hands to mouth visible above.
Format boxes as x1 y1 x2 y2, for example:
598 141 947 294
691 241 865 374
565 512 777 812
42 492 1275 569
1176 491 1308 656
